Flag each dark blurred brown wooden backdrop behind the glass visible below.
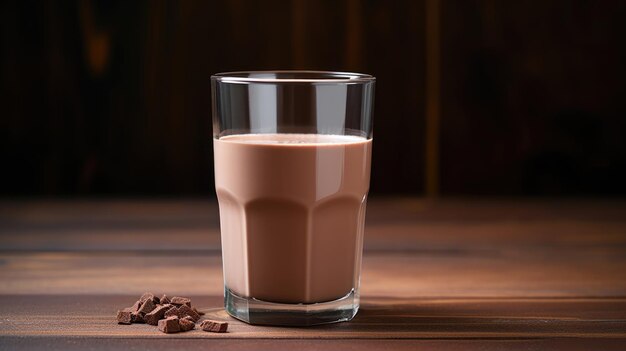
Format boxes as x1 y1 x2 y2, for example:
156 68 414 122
0 0 626 197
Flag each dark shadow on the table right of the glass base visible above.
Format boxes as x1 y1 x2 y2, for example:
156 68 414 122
310 297 626 338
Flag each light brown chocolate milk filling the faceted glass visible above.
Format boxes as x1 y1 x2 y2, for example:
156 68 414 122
214 134 372 303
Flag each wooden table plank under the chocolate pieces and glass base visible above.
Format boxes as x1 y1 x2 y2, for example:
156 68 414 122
0 295 626 339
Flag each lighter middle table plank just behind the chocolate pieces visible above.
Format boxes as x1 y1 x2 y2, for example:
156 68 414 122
0 250 626 298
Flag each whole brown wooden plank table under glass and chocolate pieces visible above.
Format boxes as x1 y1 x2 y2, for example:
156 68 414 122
0 198 626 350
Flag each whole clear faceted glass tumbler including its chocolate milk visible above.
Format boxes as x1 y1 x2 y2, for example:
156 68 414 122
211 71 375 326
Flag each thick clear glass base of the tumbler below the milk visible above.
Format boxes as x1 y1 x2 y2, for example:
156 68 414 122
224 287 359 327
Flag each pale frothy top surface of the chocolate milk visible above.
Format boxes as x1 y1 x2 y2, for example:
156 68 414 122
219 133 367 146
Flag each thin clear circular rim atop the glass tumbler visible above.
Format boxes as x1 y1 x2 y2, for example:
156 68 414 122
211 70 376 84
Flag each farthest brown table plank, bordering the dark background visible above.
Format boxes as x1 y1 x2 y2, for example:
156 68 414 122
0 198 626 252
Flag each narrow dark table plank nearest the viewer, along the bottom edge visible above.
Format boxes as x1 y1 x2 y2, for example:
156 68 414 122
0 336 624 351
